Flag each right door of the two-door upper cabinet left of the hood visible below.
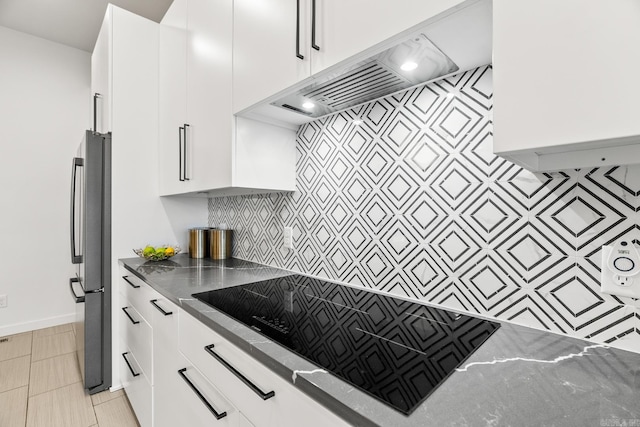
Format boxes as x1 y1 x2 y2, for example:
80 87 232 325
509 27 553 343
186 0 233 191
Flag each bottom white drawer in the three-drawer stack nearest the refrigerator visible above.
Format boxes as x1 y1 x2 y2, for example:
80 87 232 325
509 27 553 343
120 350 152 427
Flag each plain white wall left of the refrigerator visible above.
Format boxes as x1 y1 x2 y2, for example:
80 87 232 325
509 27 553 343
0 27 91 336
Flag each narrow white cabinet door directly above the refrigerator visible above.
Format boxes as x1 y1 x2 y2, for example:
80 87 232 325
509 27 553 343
91 8 112 133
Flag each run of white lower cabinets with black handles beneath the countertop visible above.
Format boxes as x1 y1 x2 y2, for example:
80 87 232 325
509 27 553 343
119 270 349 427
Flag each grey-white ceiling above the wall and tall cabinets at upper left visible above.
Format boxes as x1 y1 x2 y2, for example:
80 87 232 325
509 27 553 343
0 0 173 52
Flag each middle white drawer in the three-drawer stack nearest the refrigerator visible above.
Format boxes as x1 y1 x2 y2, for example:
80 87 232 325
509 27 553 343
120 305 153 384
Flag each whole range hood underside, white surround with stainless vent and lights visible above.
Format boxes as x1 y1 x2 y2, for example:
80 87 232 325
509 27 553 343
240 0 492 128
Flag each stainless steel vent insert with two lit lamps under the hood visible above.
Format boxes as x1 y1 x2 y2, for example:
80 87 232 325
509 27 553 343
271 33 459 118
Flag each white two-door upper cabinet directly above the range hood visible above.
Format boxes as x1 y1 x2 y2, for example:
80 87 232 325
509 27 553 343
233 0 462 113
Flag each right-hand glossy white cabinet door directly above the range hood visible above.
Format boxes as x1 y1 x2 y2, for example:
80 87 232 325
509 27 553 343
308 0 462 74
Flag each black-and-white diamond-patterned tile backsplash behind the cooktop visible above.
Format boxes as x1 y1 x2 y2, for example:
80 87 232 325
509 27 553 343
209 66 640 352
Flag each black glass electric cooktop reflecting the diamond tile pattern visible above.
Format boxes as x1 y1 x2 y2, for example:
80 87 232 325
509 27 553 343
193 275 500 415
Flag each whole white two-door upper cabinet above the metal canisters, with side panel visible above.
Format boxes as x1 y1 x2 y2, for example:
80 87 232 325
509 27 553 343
159 0 295 197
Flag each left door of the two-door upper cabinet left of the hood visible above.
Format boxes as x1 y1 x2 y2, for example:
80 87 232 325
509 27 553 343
158 0 188 195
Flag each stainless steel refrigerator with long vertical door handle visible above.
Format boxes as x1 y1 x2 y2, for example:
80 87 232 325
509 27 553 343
69 130 111 394
